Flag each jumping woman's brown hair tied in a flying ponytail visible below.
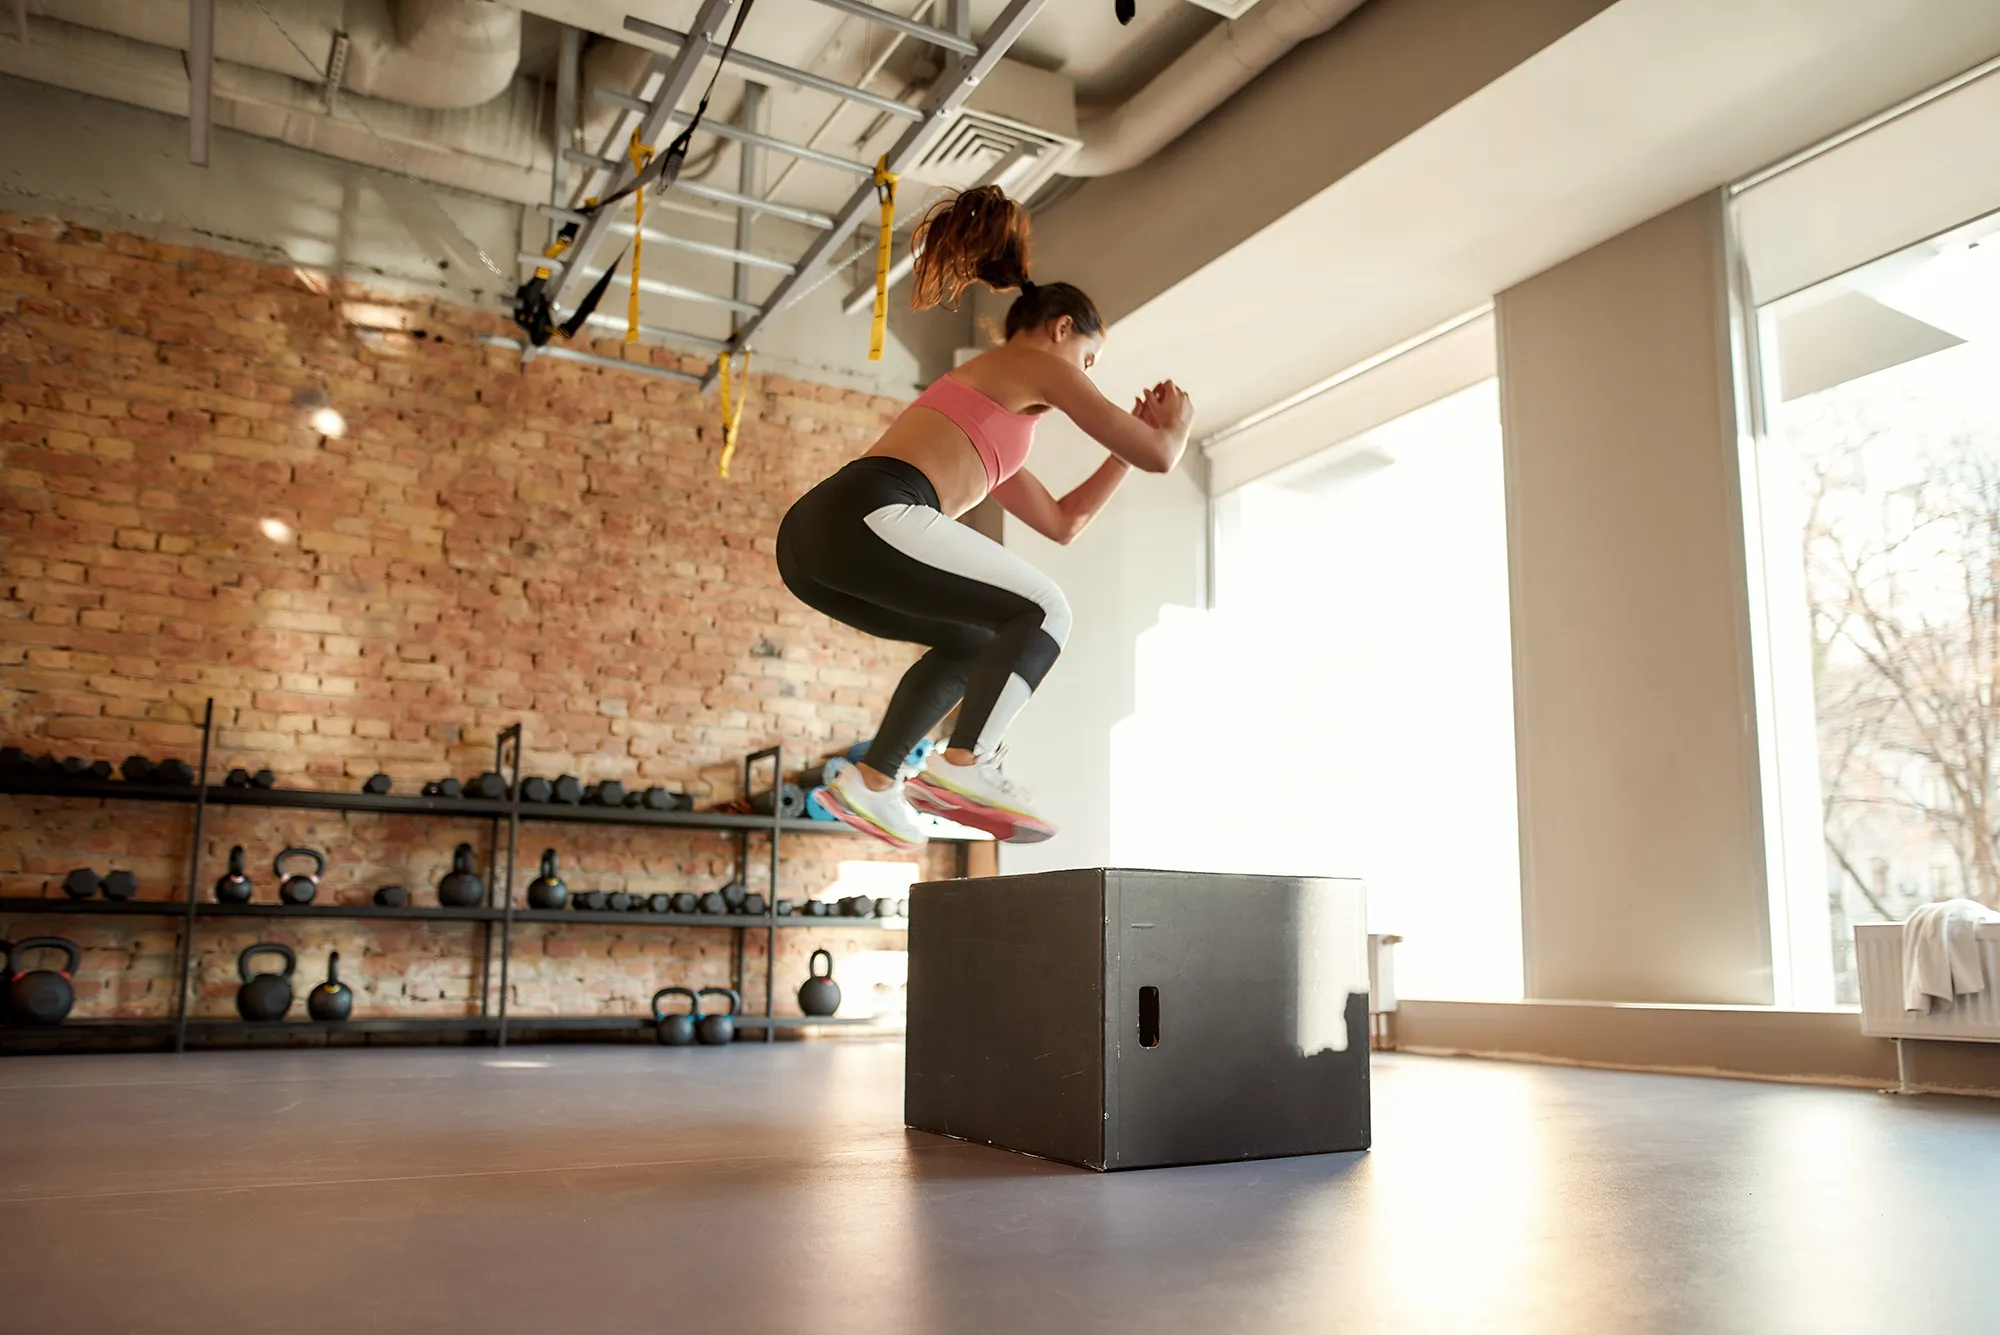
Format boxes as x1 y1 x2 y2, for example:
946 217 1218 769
910 186 1104 338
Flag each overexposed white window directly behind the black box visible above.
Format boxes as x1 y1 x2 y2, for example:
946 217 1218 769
1114 380 1522 999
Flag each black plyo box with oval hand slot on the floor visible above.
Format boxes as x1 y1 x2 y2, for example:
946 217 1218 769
904 867 1370 1169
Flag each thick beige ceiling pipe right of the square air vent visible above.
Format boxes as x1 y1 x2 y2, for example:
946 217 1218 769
1060 0 1362 176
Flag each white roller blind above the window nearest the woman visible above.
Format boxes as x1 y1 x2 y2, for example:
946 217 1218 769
1206 312 1496 496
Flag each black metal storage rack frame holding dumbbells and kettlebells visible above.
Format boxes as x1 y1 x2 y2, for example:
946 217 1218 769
0 701 976 1051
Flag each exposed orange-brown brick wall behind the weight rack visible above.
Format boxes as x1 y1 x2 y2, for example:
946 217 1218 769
0 214 952 1015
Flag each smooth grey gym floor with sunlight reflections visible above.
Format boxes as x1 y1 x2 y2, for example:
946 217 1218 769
0 1043 2000 1335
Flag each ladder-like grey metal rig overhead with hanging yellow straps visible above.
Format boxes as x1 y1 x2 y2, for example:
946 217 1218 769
508 0 1046 392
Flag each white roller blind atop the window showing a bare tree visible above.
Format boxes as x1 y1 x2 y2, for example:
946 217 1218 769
1736 70 2000 306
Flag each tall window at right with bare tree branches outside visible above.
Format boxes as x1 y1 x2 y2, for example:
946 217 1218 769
1746 205 2000 1005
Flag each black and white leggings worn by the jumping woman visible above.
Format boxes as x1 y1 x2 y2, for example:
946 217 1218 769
778 458 1070 773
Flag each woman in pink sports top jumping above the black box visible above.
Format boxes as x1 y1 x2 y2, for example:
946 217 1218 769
778 186 1194 849
